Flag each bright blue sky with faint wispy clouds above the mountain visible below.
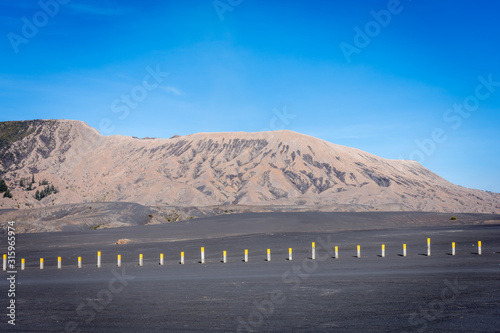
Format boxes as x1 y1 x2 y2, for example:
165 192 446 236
0 0 500 192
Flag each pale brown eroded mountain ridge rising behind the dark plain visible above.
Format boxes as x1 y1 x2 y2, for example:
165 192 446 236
0 120 500 213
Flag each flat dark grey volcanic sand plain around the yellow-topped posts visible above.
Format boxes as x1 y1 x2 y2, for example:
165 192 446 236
0 213 500 332
